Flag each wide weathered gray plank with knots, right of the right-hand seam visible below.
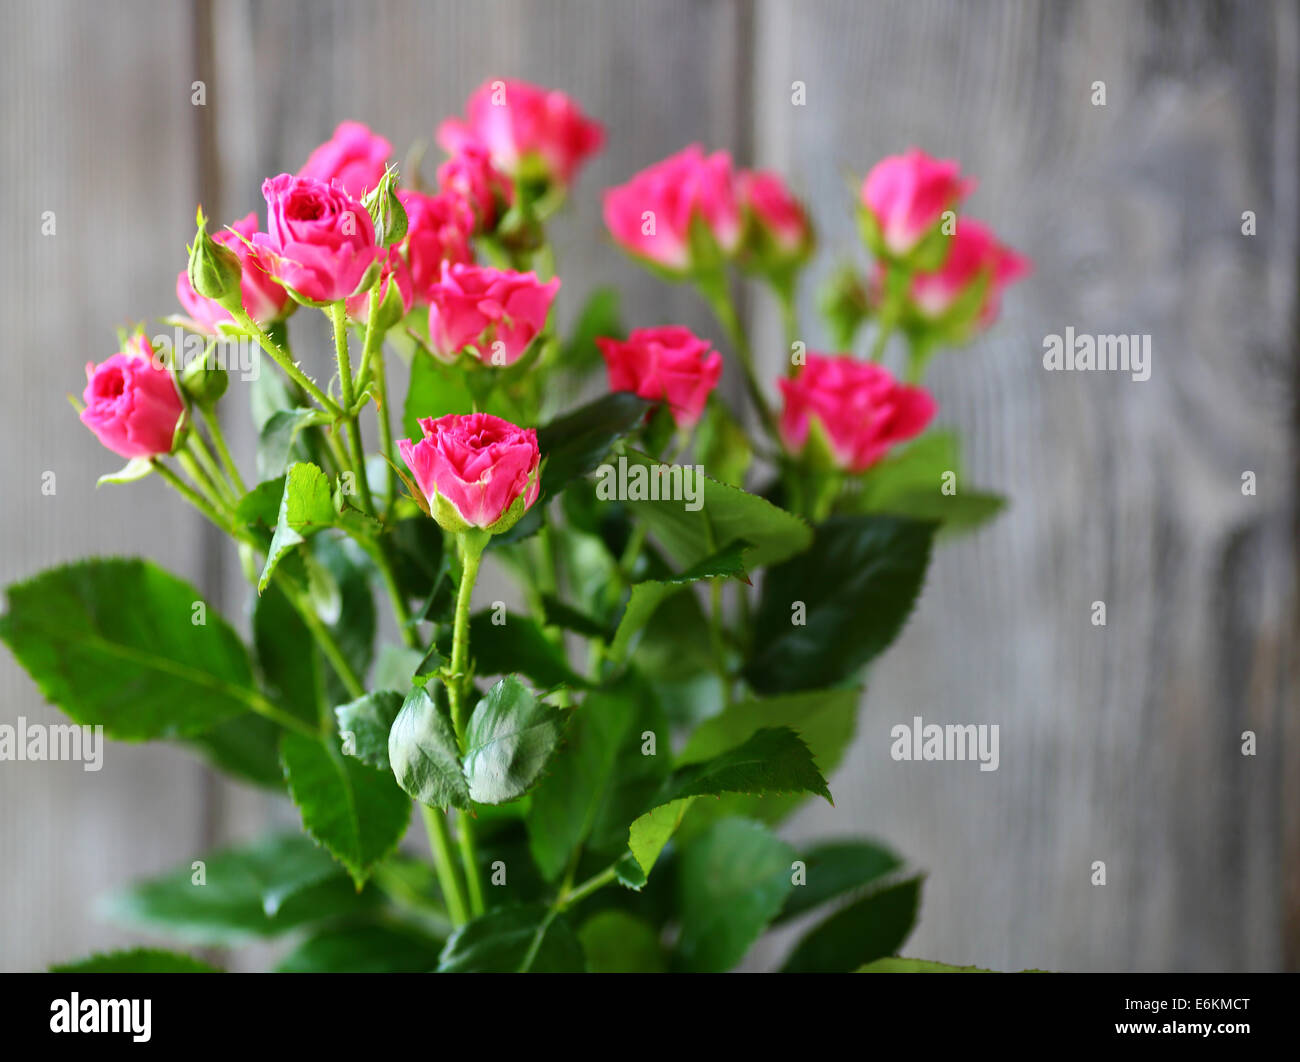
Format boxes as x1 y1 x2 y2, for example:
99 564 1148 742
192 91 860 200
754 0 1300 970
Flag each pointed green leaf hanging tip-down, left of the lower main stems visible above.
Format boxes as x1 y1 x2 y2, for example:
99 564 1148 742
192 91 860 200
280 732 411 889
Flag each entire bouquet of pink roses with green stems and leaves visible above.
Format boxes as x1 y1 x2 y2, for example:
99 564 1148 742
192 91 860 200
0 81 1027 971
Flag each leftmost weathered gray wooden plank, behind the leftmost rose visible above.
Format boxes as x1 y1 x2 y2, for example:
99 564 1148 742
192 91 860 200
0 3 213 970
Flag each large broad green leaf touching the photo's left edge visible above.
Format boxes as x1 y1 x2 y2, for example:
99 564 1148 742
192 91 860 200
0 559 260 741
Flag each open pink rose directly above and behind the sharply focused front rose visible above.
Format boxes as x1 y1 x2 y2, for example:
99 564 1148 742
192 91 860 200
429 263 560 365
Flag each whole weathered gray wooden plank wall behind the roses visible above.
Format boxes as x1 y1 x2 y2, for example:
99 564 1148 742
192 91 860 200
0 0 1300 970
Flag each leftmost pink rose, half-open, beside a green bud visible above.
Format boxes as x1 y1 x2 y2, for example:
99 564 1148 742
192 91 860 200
81 335 185 460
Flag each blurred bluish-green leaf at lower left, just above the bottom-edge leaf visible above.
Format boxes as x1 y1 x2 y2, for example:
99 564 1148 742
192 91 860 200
104 835 377 944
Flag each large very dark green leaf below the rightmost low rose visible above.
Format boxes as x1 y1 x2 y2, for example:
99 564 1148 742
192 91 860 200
744 516 935 694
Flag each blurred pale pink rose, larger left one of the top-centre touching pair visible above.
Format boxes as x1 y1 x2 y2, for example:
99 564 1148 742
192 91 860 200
605 144 741 273
